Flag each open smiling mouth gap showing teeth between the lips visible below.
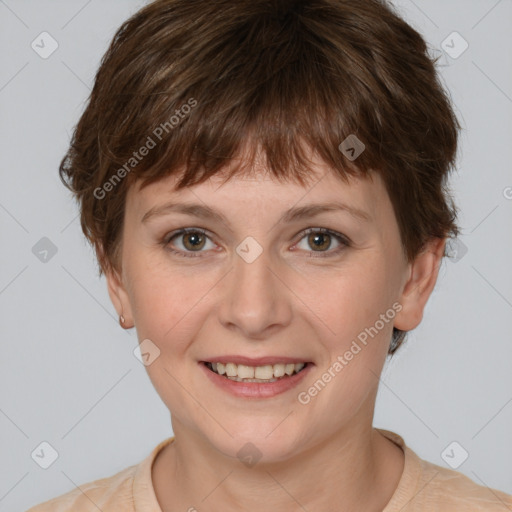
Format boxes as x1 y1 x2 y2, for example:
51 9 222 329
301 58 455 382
203 361 311 384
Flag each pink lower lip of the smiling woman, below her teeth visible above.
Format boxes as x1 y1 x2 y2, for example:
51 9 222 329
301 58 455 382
199 363 313 398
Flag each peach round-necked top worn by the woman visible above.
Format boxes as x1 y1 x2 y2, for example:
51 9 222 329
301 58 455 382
26 429 512 512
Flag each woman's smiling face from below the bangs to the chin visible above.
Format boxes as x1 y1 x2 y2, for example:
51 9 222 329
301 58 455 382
107 156 435 461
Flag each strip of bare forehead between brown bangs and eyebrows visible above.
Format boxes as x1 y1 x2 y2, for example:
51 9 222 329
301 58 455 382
126 162 391 226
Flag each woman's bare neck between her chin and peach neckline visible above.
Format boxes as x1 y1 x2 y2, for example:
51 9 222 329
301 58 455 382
153 421 404 512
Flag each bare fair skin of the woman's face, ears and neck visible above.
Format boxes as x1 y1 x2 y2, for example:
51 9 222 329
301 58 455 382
107 156 444 511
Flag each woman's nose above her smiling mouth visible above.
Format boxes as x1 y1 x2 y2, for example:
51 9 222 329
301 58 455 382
218 245 292 340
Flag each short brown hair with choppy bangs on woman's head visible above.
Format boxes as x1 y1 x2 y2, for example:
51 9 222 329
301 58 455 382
59 0 460 353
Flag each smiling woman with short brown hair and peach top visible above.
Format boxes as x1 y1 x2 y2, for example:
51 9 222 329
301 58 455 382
26 0 512 512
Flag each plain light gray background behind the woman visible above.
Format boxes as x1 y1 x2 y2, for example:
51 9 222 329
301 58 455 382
0 0 512 511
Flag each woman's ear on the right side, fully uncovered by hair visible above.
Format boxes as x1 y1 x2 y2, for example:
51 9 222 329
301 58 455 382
394 238 446 331
